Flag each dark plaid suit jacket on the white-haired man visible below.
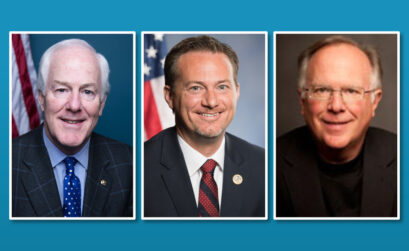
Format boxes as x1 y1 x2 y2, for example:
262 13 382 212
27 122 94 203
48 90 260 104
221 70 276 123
12 126 133 217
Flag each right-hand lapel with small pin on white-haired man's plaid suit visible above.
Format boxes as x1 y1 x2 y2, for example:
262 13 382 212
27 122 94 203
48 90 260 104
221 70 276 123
82 134 112 216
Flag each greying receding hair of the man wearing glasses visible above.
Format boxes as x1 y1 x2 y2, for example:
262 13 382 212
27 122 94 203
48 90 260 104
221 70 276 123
298 36 383 94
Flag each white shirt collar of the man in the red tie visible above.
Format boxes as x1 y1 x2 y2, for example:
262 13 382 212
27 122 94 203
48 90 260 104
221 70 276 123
178 134 225 176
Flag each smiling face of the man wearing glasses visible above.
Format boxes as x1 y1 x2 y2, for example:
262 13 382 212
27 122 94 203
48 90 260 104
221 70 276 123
301 43 382 153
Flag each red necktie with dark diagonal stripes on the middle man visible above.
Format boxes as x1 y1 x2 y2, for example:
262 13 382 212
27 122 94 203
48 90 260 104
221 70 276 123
198 159 219 217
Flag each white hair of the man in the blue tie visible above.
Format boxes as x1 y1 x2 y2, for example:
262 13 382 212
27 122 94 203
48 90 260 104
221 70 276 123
37 39 110 101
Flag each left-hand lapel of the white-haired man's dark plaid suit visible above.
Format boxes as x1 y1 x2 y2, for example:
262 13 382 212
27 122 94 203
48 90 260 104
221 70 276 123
21 126 63 217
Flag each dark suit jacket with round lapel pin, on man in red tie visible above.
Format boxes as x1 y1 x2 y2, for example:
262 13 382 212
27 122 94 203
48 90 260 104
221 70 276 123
144 127 265 217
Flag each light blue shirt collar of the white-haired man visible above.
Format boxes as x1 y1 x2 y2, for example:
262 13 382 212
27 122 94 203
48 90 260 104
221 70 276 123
43 127 90 170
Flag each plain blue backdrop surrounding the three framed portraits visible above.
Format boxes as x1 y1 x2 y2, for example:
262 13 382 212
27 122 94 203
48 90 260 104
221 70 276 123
0 0 409 251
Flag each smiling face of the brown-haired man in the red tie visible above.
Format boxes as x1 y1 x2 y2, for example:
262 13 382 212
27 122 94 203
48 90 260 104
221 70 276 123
165 51 240 142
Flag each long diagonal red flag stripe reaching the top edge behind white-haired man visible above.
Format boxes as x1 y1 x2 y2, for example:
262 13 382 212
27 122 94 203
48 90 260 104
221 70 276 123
12 34 40 129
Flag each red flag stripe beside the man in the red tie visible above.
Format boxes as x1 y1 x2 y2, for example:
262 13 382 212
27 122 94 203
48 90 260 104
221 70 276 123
143 81 162 140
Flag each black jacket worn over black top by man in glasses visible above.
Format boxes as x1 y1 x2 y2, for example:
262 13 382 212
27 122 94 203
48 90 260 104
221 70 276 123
276 126 397 217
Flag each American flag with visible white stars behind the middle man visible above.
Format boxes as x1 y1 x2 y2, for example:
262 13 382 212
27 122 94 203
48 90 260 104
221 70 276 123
143 33 175 140
